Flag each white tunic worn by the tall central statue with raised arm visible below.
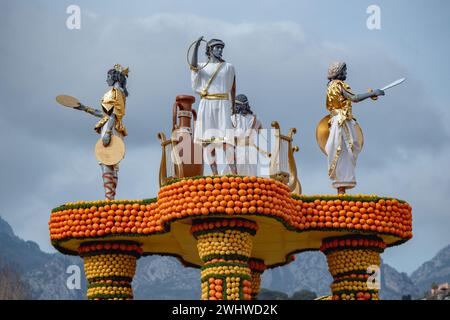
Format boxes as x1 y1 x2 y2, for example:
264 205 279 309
191 62 235 144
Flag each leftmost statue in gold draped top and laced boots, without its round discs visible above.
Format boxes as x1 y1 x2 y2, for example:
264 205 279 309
76 64 128 200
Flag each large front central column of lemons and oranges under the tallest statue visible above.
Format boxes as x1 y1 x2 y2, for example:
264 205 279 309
191 218 258 300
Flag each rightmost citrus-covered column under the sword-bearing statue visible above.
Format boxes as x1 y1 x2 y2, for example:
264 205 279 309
320 235 386 300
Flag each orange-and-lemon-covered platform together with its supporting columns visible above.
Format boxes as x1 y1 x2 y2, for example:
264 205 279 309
49 176 412 300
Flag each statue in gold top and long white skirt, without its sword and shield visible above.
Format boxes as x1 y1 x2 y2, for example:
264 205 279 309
325 62 384 193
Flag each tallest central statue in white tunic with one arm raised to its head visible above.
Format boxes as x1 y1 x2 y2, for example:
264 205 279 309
191 38 236 175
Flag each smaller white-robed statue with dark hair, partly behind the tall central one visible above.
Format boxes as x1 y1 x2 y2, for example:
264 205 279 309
231 94 262 176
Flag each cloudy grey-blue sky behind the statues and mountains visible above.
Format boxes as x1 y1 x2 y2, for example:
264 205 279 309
0 0 450 272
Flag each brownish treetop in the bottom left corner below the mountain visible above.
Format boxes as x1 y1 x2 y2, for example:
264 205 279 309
0 261 30 300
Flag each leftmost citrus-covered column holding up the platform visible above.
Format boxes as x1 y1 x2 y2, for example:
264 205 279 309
78 241 142 300
